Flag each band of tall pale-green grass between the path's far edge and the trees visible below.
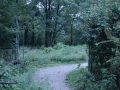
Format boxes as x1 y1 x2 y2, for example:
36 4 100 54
21 44 88 65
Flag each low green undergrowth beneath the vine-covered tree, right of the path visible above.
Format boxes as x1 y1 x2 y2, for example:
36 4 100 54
67 68 119 90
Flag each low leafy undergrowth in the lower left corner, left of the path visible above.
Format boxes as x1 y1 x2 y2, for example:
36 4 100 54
0 60 50 90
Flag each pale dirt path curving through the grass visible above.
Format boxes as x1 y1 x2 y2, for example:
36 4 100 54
34 63 88 90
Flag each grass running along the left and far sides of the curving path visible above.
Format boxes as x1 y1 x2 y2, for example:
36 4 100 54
7 44 87 90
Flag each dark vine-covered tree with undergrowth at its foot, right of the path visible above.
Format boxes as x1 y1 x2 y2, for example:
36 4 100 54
68 0 120 90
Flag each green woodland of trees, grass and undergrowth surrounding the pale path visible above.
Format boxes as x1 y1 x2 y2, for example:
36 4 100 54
0 0 120 90
